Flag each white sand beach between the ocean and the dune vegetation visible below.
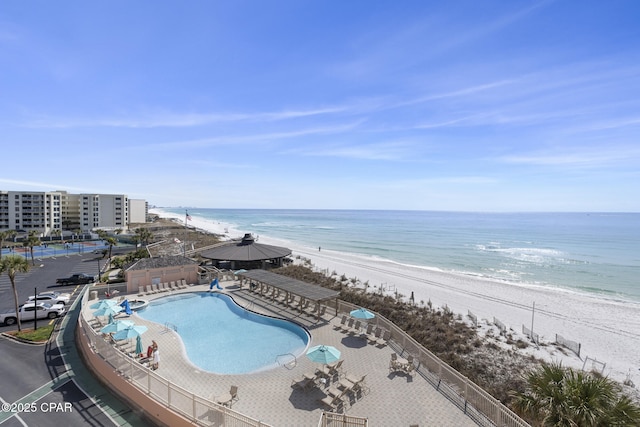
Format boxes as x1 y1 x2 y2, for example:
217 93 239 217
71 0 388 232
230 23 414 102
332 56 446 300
152 210 640 386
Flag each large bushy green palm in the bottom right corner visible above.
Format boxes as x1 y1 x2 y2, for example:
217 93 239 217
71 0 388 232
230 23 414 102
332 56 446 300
513 364 640 427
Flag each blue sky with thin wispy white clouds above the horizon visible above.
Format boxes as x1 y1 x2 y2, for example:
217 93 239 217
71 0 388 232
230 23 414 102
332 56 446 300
0 0 640 212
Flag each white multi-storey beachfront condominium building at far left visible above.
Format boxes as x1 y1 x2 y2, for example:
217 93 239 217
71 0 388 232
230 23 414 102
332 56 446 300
0 190 148 236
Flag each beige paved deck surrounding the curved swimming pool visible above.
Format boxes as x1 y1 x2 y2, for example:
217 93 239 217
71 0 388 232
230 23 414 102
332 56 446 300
85 281 476 427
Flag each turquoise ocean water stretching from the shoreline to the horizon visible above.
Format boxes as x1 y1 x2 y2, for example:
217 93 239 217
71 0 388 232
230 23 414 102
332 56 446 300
162 208 640 302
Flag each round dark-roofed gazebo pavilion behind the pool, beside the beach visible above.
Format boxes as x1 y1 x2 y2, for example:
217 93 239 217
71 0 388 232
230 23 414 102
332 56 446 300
200 233 291 270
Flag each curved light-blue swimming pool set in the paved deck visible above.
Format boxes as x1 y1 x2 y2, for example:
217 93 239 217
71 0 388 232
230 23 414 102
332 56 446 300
138 292 310 374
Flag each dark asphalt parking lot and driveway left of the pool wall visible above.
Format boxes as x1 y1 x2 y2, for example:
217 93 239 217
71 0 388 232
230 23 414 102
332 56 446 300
0 253 148 427
